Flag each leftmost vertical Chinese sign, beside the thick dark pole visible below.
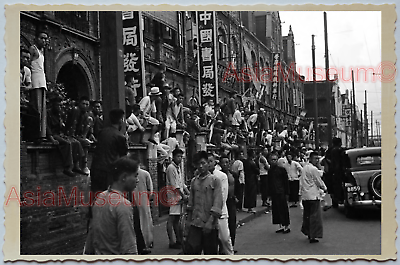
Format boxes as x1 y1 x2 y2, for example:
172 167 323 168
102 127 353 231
122 11 146 98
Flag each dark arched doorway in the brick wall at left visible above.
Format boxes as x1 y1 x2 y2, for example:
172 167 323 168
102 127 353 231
57 61 90 100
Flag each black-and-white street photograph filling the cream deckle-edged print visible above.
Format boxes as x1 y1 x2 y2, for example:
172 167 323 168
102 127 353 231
5 5 396 259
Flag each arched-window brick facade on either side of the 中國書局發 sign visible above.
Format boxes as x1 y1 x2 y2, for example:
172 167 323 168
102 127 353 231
143 11 305 129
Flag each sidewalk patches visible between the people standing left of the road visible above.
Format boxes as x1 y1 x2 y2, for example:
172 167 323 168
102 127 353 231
151 195 268 255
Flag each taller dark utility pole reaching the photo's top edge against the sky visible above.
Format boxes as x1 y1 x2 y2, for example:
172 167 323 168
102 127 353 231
324 12 336 145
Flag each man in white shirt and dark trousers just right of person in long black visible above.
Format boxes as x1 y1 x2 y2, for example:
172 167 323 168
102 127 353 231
285 153 303 208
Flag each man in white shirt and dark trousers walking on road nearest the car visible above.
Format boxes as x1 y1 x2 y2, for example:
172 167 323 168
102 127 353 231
300 152 327 243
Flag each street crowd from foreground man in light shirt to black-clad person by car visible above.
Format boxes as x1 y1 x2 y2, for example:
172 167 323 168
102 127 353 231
175 138 346 255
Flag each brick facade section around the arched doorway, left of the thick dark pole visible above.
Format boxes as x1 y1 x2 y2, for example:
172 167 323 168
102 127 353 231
20 11 101 100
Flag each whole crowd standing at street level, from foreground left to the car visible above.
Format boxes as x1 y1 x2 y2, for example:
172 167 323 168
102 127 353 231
85 129 346 255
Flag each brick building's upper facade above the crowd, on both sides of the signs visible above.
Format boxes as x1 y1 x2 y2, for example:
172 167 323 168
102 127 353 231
21 11 305 128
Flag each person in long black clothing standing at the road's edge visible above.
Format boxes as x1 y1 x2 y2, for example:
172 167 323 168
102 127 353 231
268 153 290 234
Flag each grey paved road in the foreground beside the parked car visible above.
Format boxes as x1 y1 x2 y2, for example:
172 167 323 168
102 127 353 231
235 203 381 255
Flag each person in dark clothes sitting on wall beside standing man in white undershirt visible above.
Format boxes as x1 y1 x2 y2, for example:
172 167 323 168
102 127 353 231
46 98 85 177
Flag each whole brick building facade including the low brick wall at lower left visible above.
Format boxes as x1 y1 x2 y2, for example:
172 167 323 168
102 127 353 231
20 11 304 254
